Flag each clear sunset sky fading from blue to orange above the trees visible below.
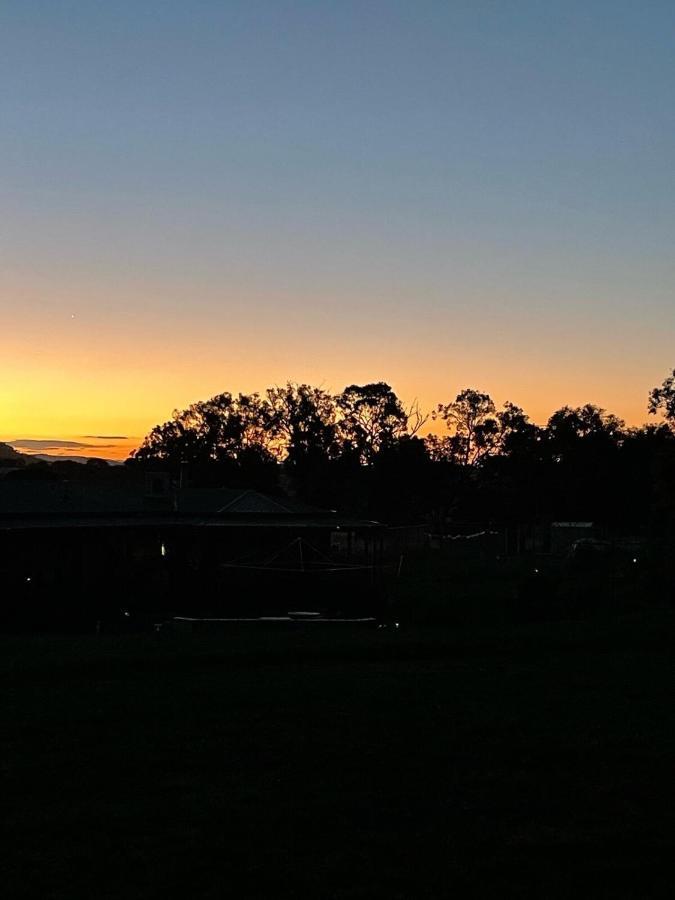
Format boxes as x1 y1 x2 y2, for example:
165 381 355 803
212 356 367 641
0 0 675 458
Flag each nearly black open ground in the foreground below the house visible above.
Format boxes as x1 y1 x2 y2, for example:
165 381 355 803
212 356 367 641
0 613 675 900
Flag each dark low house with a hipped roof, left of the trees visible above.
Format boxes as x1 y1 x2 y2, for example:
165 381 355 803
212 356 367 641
0 482 385 627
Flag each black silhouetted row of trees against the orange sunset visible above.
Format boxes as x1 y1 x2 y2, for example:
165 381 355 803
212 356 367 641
128 371 675 522
